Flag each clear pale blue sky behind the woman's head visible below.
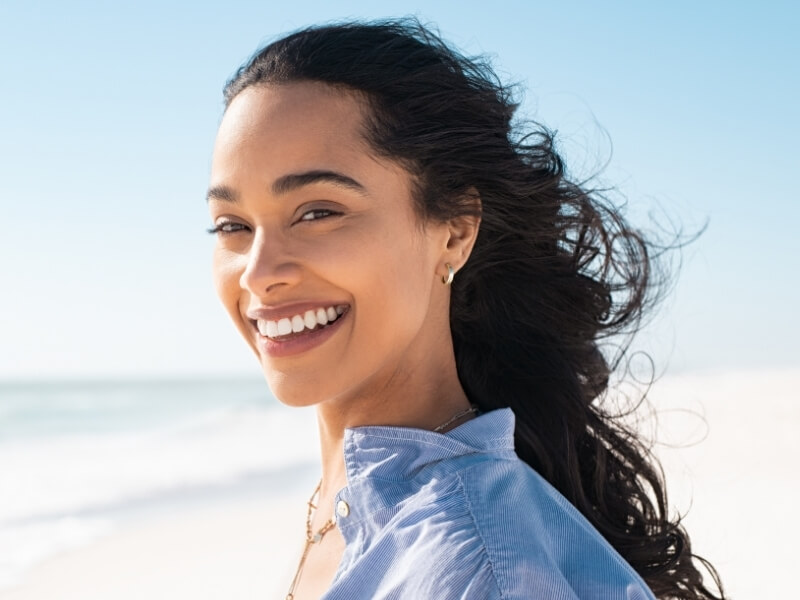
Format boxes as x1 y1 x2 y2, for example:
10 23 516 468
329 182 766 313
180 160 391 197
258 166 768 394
0 0 800 378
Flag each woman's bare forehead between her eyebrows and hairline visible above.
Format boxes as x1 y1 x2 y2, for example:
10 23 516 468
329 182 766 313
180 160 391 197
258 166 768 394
214 82 369 167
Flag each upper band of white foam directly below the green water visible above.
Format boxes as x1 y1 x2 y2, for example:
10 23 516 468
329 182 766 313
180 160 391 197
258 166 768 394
0 407 318 526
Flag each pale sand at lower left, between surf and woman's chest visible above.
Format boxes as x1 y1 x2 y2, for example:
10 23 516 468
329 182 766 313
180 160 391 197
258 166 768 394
0 497 305 600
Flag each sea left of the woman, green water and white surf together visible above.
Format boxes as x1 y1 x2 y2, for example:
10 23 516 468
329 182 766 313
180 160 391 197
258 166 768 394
0 380 318 589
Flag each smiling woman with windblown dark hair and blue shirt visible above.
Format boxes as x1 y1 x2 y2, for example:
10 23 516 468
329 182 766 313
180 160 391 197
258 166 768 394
208 21 719 600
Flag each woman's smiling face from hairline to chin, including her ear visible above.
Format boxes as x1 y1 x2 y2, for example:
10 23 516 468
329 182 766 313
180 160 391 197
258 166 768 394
208 82 456 405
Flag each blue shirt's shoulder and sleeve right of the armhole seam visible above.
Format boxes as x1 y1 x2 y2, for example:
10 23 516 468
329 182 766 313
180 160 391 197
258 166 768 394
446 459 652 600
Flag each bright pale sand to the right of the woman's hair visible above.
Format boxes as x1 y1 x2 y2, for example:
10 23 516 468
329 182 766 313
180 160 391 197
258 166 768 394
651 370 800 600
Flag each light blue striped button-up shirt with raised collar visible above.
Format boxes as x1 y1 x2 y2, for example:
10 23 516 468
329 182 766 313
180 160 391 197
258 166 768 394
323 409 653 600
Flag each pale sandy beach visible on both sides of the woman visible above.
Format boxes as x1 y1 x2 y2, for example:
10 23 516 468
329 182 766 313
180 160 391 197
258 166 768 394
0 371 800 600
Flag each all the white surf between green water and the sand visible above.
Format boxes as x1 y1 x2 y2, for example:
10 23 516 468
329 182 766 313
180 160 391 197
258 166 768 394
0 406 319 589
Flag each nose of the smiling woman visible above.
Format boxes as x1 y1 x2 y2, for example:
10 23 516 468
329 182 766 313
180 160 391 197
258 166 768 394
239 230 301 298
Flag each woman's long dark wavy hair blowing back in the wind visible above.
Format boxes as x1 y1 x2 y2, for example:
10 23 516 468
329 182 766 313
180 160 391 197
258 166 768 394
225 19 724 599
